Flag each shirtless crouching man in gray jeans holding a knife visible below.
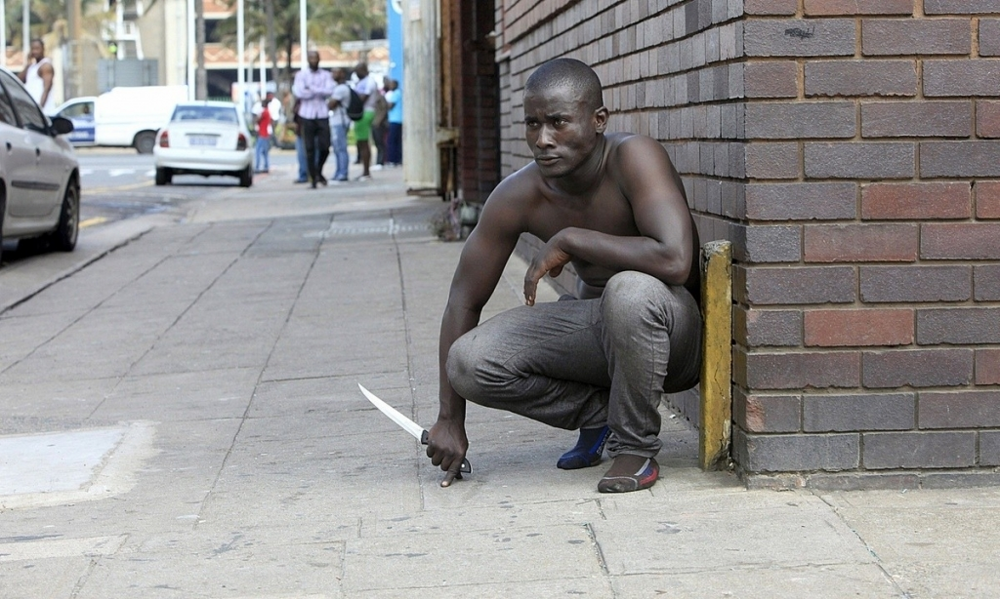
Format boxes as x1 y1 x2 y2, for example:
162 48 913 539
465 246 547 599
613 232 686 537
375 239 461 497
427 59 701 493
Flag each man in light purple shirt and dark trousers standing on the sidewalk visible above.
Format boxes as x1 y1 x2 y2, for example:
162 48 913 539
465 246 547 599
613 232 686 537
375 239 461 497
292 50 334 189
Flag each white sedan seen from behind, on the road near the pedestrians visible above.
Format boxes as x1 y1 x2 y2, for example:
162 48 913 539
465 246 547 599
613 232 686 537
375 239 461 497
153 102 253 187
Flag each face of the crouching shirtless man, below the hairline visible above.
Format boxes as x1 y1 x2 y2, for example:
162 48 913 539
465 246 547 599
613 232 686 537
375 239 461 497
524 86 606 177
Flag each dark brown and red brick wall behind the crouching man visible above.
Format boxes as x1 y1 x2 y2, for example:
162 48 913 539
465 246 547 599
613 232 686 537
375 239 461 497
497 0 1000 487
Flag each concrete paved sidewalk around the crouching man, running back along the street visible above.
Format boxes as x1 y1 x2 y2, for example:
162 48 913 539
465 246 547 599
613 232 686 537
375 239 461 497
0 164 1000 599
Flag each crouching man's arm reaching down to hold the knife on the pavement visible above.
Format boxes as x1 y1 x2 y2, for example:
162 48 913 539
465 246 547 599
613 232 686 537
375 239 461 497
427 181 524 487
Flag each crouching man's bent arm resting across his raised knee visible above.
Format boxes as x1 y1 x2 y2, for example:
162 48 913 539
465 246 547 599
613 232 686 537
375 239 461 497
524 135 694 305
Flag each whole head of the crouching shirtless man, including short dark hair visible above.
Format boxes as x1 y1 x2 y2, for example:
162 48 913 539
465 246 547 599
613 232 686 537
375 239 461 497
524 58 608 177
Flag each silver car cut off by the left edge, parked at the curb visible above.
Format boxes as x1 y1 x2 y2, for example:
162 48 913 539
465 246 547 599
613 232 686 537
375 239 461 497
0 69 80 266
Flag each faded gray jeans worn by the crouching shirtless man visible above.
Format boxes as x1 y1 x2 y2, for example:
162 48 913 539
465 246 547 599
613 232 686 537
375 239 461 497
447 271 701 457
